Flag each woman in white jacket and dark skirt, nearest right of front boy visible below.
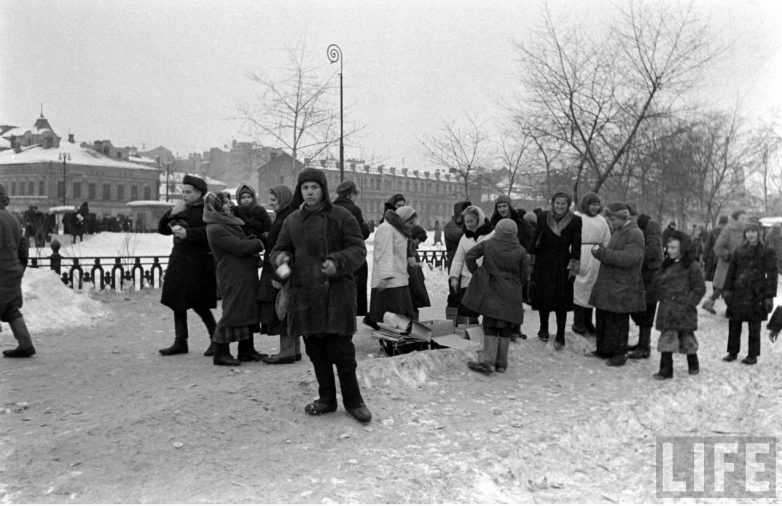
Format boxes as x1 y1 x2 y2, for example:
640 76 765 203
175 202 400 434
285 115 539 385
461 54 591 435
364 206 417 330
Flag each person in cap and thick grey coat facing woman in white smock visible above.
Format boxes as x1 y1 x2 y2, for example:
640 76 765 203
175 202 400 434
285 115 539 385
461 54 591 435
589 202 646 366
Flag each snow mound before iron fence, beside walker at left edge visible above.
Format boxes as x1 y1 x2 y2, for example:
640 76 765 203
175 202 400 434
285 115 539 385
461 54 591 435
22 269 109 334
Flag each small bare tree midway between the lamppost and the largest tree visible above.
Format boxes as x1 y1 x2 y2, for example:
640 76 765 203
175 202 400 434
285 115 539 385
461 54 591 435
421 115 489 200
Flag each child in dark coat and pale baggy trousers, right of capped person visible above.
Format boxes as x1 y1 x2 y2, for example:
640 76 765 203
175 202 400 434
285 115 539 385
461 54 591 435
653 230 706 380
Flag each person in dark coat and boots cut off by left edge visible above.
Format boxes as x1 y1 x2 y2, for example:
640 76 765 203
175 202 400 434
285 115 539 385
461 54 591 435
0 184 35 358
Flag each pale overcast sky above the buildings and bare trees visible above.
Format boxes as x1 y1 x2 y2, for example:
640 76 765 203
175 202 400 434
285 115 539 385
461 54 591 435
0 0 782 172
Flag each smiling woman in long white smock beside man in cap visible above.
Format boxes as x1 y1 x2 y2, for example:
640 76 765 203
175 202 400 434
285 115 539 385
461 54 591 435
573 192 611 335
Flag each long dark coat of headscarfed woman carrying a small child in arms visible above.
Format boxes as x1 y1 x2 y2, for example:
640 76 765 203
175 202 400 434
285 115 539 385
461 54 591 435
206 222 263 327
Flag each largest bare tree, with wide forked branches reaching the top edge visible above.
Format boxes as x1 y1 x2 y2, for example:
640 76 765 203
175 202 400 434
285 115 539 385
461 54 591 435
517 2 714 197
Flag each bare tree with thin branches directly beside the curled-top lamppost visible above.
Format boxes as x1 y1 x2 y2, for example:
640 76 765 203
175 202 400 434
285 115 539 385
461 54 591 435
237 46 344 170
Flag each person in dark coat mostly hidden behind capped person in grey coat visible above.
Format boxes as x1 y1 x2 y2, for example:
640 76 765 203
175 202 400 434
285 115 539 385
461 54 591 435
627 204 670 359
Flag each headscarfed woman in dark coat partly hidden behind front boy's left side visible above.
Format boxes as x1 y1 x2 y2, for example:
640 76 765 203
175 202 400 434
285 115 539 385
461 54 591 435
258 185 301 364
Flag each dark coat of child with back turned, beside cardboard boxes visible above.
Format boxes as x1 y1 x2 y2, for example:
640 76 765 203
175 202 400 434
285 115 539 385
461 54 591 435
462 236 529 324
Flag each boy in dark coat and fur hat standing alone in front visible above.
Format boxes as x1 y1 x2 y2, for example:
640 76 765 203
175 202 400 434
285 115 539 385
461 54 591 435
272 169 372 423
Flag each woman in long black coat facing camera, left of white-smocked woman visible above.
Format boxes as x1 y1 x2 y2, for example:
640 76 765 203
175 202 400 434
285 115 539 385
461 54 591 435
532 192 581 349
